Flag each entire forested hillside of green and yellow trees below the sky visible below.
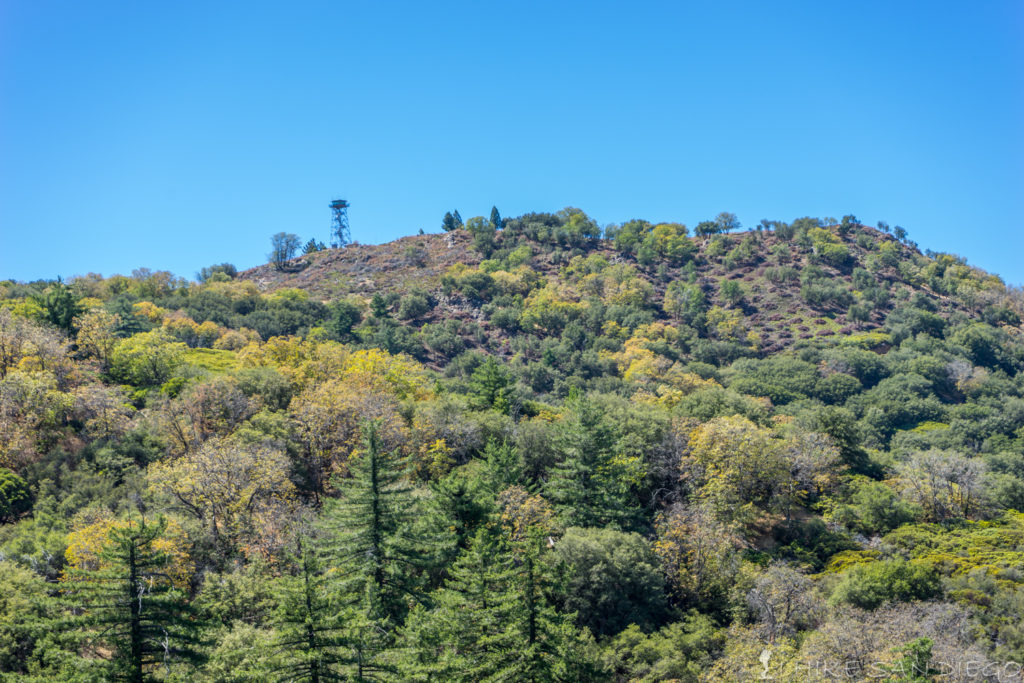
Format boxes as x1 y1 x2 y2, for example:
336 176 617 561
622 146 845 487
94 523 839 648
0 209 1024 682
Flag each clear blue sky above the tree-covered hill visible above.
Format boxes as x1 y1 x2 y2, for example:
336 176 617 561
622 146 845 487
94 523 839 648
0 0 1024 284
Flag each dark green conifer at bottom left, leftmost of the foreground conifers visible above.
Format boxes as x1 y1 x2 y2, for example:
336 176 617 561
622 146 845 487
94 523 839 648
65 519 199 683
